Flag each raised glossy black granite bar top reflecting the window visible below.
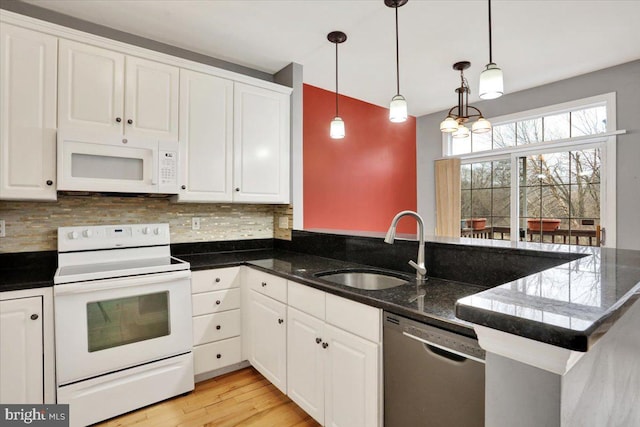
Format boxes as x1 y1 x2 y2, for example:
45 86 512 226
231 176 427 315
456 248 640 351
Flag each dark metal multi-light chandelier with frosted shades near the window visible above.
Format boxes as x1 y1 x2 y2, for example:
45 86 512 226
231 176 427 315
440 61 491 138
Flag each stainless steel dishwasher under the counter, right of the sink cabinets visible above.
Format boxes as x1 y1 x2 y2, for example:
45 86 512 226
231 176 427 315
383 312 484 427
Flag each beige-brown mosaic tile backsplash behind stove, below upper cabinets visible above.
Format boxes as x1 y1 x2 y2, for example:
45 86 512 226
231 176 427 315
0 194 286 253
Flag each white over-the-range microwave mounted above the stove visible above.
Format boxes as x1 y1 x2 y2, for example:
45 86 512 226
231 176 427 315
57 130 179 194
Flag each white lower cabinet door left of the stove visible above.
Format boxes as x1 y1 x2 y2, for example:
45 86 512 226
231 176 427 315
0 297 44 403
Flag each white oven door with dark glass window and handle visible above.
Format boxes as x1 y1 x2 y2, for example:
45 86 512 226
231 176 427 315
54 271 192 386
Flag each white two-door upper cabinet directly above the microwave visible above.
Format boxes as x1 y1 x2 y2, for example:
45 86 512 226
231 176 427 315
58 40 179 140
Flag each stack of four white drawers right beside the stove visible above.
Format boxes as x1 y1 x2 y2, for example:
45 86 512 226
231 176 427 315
191 267 242 375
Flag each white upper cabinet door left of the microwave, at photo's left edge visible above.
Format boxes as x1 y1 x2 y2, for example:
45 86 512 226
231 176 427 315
0 23 58 200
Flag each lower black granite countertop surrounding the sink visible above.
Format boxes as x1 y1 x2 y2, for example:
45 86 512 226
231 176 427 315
179 250 486 337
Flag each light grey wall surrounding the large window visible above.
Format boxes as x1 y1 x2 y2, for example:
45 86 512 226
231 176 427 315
416 60 640 250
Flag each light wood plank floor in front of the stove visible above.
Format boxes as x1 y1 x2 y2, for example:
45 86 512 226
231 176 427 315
96 368 320 427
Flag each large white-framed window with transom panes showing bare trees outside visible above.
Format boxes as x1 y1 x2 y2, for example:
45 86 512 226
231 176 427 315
443 94 622 246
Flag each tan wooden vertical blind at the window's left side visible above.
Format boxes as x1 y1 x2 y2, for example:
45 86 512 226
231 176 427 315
435 159 460 237
